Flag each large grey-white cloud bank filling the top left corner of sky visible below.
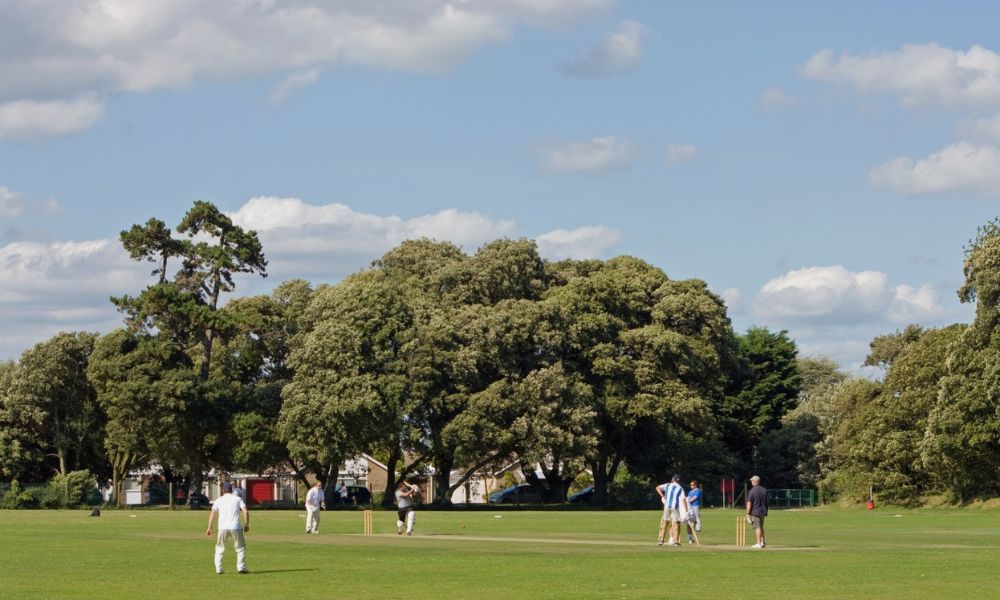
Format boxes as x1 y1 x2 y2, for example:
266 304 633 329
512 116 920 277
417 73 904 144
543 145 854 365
0 0 614 137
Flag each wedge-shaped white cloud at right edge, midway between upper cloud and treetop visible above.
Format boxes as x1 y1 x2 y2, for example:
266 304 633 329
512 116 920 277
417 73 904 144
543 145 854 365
868 142 1000 197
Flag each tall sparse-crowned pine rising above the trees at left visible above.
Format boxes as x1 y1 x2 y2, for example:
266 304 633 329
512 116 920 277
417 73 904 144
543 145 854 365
111 200 267 486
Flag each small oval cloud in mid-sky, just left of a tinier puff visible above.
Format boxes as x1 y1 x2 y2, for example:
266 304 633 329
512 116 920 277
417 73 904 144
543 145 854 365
536 136 638 175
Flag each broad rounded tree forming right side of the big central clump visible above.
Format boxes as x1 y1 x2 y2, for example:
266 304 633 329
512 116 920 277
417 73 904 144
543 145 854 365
544 257 734 503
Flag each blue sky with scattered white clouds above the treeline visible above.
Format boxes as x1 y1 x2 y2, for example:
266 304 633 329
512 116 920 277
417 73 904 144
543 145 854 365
0 0 1000 372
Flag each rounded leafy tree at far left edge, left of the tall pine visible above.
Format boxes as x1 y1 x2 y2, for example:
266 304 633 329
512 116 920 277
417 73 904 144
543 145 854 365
2 333 104 475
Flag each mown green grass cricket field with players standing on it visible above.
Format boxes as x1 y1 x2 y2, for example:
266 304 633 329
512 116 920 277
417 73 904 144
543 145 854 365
0 508 1000 600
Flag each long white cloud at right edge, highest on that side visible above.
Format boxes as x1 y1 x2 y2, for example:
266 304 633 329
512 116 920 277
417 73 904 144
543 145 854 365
801 44 1000 108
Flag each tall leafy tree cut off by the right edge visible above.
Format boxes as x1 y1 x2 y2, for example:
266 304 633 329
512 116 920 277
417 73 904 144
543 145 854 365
922 219 1000 500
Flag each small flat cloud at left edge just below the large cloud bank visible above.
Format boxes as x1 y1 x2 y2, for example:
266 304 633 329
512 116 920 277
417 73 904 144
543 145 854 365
0 96 104 139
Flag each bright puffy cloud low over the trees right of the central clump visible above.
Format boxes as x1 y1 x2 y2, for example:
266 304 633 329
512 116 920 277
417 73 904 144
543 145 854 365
754 265 945 324
